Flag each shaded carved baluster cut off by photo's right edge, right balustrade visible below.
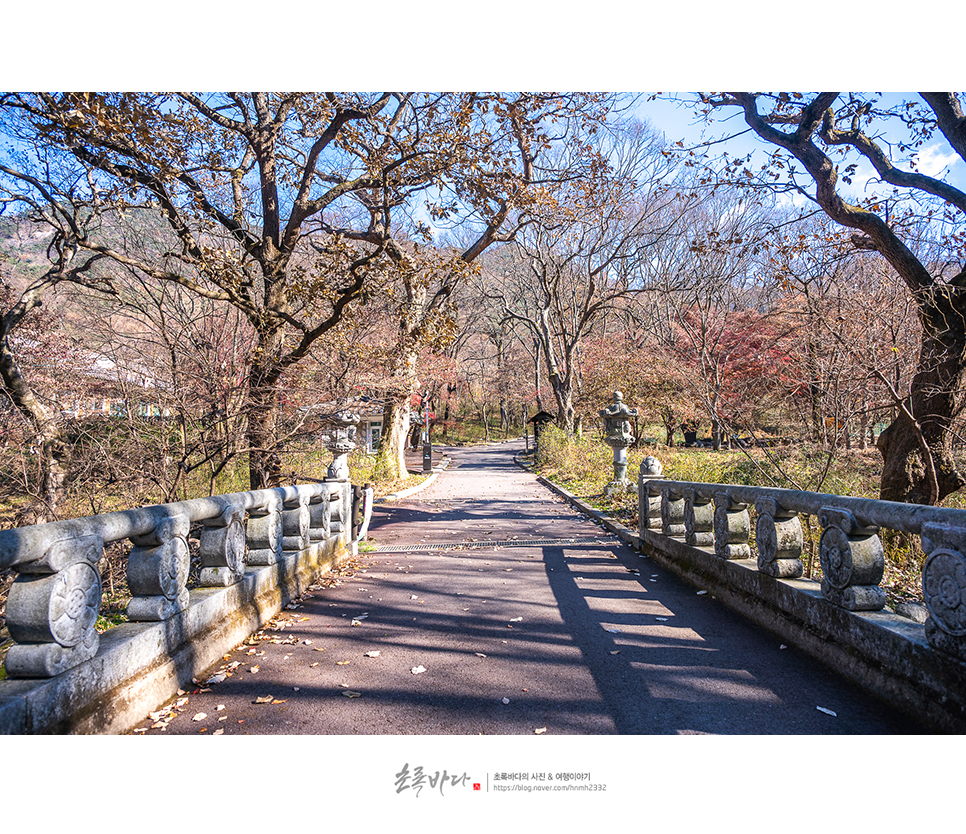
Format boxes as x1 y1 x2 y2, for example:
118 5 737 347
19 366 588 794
922 524 966 660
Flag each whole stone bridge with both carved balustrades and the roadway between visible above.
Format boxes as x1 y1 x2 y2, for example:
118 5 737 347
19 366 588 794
0 432 966 734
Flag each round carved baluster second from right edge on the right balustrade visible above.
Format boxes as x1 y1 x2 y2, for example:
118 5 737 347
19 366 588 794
818 507 885 611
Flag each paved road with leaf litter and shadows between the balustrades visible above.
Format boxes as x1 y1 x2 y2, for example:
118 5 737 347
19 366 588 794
132 443 924 735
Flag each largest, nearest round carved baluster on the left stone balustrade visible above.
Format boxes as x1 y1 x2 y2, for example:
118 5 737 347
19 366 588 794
5 536 104 678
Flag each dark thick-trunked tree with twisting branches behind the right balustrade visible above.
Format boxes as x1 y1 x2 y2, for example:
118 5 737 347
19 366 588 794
700 92 966 504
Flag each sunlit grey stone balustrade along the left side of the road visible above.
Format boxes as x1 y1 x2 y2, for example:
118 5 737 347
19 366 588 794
0 473 371 733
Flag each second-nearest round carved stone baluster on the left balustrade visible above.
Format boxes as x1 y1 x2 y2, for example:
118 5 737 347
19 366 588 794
127 516 190 622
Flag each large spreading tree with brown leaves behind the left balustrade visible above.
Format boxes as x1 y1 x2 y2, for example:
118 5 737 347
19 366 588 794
0 92 628 487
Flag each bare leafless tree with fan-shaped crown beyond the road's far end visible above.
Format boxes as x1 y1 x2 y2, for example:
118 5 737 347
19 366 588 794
479 124 698 433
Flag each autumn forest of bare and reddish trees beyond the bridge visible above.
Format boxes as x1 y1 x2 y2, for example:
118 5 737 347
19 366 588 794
0 93 964 524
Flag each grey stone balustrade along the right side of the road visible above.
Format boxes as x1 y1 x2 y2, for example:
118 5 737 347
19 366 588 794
638 458 966 732
